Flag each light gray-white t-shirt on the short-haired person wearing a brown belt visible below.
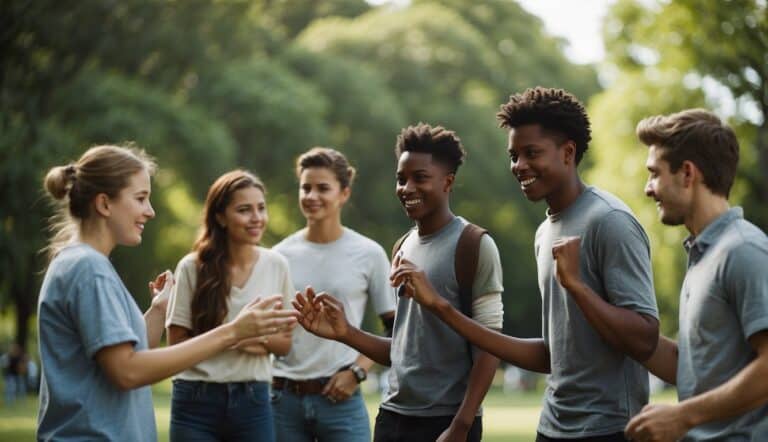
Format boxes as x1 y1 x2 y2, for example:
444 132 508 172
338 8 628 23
272 227 395 379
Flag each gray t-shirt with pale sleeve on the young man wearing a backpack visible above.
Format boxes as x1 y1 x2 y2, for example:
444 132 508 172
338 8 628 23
381 217 504 416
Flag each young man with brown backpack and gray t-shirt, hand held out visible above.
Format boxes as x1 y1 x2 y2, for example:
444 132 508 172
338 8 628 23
296 124 503 442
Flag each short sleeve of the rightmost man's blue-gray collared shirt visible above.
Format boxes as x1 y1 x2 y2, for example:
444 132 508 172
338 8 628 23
723 243 768 338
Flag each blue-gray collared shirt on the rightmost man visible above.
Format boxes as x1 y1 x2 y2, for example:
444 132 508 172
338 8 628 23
677 207 768 441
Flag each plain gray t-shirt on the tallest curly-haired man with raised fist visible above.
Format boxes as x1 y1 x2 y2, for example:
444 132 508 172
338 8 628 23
535 187 658 438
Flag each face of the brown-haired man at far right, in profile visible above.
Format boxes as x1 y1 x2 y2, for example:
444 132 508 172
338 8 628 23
645 145 690 226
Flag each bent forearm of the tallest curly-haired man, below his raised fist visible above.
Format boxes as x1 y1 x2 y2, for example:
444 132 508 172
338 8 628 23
566 282 659 362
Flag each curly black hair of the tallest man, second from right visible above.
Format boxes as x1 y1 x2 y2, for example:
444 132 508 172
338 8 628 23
496 86 592 164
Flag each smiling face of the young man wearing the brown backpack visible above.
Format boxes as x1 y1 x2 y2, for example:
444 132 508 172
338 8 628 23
395 151 454 221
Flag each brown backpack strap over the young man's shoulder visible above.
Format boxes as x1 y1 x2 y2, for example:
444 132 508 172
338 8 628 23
454 223 488 318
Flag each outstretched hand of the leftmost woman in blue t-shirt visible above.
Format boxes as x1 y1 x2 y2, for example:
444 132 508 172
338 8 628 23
232 295 298 340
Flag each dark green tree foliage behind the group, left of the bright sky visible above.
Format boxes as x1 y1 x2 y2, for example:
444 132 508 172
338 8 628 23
0 0 598 348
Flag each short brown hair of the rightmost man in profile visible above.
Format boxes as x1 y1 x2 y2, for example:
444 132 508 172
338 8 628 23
636 109 739 198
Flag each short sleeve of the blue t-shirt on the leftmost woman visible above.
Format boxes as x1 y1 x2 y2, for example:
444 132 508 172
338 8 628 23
70 275 139 358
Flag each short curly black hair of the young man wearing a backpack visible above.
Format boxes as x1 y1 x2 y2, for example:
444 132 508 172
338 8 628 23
395 123 466 174
